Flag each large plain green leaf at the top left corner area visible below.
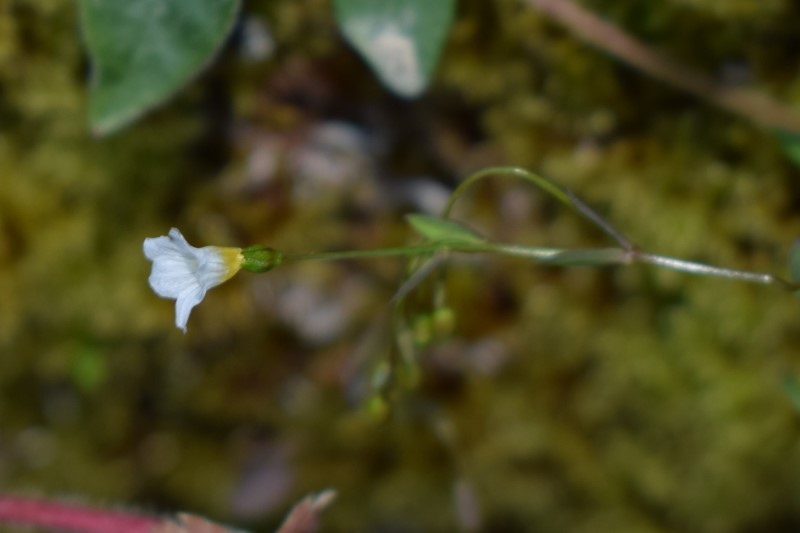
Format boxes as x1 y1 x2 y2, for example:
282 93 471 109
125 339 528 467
80 0 240 134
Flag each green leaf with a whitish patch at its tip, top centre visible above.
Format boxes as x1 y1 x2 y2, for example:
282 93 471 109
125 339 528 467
334 0 455 98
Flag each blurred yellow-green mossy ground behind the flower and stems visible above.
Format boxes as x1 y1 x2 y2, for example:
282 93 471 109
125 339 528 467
0 0 800 533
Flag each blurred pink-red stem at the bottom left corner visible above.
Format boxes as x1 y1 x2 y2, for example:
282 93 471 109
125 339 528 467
0 495 159 533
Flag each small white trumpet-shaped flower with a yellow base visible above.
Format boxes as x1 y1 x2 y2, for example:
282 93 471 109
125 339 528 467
144 228 244 333
